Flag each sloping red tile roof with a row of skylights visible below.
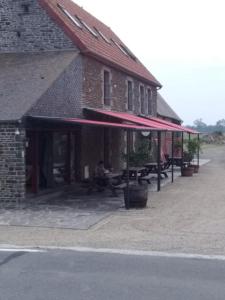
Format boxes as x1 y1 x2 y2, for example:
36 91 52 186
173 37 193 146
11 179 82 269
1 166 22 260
39 0 161 87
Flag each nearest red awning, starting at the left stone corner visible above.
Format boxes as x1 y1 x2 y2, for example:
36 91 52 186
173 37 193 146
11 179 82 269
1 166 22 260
27 116 157 131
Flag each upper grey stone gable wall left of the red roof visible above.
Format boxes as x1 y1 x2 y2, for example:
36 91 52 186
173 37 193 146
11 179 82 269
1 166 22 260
0 0 75 53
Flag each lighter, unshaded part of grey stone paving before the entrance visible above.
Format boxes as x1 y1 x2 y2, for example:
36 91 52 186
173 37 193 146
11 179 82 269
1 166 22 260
0 195 123 230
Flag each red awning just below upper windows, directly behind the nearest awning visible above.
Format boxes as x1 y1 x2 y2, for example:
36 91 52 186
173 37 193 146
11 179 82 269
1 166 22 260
85 108 183 131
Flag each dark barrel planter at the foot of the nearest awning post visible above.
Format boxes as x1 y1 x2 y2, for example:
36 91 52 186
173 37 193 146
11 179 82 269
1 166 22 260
124 184 148 208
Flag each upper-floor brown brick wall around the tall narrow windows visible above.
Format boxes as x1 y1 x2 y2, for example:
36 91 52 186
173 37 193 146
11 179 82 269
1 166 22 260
82 57 157 116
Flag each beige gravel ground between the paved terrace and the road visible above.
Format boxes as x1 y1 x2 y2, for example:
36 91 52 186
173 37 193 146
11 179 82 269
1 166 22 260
0 146 225 255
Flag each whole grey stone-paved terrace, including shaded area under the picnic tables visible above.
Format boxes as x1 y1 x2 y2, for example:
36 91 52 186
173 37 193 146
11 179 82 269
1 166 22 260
0 168 180 230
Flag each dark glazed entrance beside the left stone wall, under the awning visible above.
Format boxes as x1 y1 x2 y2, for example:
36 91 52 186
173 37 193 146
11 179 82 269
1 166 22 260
26 130 80 194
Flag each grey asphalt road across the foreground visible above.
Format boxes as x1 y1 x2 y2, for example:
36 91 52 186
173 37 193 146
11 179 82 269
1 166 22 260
0 251 225 300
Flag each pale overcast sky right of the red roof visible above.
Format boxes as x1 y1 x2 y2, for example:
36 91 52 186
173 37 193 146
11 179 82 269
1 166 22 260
75 0 225 125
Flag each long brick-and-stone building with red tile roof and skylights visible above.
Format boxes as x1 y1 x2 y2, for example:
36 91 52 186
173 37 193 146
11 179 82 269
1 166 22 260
0 0 182 201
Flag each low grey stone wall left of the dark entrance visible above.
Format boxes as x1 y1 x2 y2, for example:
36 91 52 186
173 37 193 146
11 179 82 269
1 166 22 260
0 124 25 202
